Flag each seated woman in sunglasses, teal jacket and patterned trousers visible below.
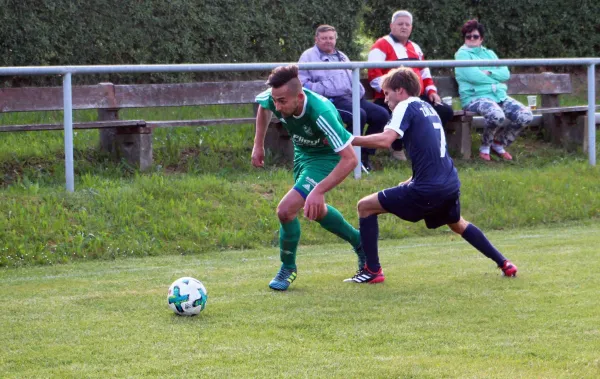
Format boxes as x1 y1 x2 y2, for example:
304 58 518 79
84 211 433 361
454 20 533 161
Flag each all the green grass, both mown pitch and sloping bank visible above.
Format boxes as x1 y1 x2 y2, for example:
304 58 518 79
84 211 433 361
0 73 600 378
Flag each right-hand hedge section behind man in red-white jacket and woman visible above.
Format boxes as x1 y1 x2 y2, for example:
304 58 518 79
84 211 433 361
364 0 600 59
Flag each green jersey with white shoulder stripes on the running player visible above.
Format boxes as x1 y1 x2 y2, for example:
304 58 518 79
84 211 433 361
256 88 352 163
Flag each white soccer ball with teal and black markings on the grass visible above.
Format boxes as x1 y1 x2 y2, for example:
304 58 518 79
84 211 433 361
167 277 208 316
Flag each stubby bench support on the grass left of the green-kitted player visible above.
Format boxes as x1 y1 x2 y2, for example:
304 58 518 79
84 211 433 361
115 128 152 171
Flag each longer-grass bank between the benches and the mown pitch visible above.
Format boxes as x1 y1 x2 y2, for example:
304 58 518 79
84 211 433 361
0 101 600 266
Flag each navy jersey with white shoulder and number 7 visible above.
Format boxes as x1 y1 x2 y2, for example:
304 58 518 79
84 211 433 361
385 97 460 197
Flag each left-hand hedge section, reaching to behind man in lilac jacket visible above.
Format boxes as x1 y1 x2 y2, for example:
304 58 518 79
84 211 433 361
0 0 364 85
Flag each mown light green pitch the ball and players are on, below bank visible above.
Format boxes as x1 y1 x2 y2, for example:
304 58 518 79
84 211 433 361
0 223 600 378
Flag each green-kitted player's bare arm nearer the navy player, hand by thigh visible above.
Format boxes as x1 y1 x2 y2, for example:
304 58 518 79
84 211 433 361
304 145 358 221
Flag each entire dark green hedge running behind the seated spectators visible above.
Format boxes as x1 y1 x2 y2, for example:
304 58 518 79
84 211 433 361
0 0 600 85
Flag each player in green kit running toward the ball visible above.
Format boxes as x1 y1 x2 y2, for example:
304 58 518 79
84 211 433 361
252 65 365 291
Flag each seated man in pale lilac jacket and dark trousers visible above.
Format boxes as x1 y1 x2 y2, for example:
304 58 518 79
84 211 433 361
298 25 390 170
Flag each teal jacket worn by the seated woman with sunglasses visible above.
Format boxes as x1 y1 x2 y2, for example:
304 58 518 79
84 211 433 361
454 45 510 108
